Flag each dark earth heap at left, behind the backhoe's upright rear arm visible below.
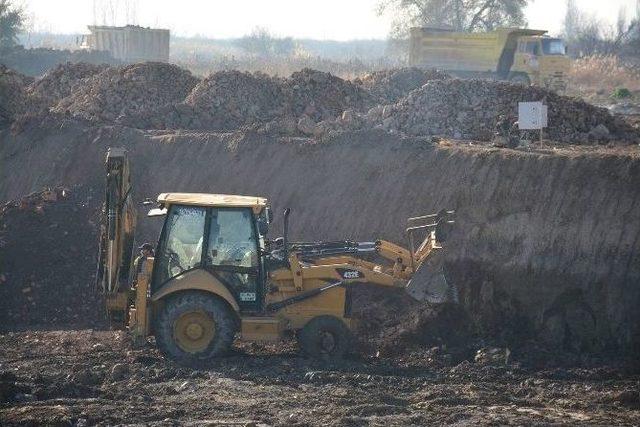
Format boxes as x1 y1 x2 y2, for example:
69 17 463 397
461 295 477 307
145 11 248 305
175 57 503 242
0 188 102 329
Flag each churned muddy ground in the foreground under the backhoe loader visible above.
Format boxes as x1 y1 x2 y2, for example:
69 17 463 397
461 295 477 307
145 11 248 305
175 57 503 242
0 330 640 426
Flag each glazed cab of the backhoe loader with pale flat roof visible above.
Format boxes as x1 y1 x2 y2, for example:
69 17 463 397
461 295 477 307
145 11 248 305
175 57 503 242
151 193 267 312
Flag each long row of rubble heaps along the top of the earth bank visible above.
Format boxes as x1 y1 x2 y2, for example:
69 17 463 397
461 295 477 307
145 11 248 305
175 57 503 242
4 63 624 146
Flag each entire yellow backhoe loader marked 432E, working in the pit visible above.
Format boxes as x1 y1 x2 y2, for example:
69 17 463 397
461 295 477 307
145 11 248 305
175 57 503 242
97 148 456 365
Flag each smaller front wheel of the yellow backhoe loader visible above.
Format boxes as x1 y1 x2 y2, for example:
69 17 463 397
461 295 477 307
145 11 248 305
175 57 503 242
298 316 352 360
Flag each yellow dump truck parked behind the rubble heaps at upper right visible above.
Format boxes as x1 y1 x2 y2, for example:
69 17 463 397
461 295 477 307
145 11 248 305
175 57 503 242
409 28 571 91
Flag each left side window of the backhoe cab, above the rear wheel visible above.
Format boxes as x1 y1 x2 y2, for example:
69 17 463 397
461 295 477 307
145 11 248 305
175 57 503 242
156 205 206 283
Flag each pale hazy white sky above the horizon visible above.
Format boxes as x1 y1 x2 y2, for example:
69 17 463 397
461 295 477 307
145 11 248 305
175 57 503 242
17 0 636 40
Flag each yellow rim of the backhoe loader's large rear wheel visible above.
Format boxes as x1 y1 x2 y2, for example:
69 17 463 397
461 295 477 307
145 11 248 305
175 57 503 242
173 311 216 353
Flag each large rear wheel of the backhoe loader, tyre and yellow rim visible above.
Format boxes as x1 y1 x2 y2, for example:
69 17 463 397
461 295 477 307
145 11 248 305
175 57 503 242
155 291 236 366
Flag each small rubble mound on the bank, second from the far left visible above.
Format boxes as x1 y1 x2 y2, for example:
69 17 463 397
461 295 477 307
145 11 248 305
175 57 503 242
27 62 107 107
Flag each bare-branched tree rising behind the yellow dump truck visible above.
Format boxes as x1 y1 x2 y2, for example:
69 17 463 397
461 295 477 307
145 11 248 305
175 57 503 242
378 0 529 37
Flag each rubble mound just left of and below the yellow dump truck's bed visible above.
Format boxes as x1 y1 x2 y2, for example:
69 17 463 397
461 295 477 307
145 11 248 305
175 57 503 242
354 67 451 104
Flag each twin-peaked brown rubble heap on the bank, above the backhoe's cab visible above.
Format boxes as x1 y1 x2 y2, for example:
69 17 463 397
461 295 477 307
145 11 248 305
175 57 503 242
125 69 372 130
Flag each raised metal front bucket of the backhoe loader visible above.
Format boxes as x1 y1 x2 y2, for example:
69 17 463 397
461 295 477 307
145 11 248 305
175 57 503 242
406 250 458 304
